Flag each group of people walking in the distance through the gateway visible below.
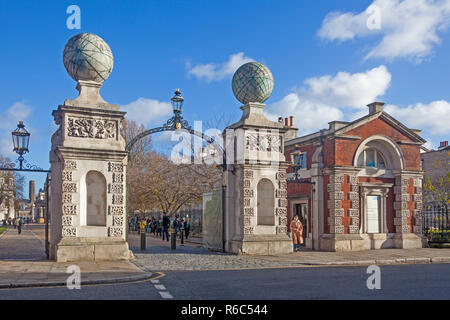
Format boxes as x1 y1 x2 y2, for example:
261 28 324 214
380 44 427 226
129 213 191 241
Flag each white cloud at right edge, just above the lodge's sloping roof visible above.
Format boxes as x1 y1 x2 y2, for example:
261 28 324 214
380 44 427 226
384 100 450 135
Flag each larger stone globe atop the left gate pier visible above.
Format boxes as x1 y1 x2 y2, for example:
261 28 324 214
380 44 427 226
63 33 114 83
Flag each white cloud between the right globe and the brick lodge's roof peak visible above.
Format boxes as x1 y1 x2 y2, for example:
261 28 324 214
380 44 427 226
266 66 391 134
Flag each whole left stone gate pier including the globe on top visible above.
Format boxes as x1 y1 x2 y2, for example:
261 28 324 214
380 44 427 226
50 33 132 262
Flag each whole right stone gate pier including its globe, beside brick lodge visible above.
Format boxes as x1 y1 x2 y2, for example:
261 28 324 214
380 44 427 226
224 62 293 255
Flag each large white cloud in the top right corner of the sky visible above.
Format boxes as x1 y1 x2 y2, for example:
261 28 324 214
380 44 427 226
318 0 450 62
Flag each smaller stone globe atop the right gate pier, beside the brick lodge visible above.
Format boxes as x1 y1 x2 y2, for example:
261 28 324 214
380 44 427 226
232 62 273 104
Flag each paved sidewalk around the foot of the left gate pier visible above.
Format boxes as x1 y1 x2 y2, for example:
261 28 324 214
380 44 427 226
0 225 151 288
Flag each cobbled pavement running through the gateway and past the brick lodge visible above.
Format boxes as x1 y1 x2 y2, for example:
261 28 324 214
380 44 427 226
129 234 450 271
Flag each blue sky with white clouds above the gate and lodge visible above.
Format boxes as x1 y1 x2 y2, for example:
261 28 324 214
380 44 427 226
0 0 450 194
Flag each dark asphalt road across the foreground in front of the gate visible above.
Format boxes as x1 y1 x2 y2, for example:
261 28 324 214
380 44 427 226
0 264 450 300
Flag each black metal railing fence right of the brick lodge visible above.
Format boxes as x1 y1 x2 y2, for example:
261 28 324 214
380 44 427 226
423 204 450 242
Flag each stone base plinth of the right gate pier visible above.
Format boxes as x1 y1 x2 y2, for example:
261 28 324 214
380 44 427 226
227 235 293 255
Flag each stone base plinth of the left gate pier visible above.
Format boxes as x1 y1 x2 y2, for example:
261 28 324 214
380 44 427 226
53 238 133 262
